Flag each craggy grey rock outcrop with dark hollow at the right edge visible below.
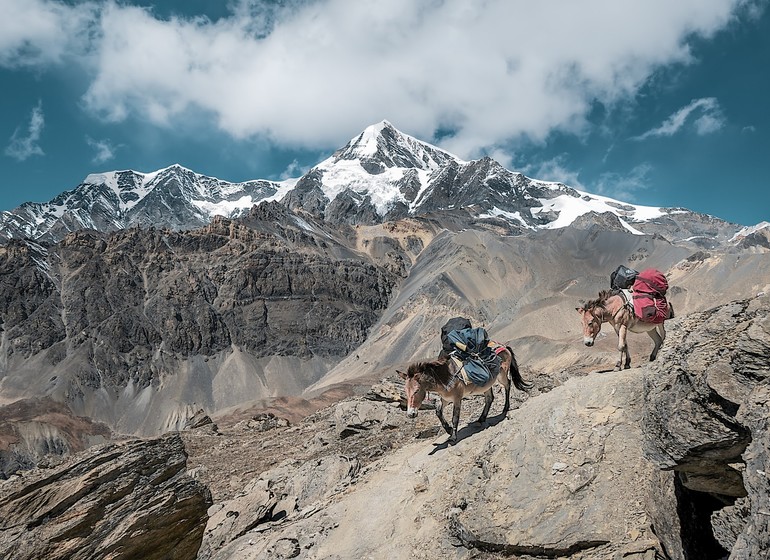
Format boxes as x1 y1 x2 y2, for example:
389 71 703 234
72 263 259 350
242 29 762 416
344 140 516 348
644 296 770 560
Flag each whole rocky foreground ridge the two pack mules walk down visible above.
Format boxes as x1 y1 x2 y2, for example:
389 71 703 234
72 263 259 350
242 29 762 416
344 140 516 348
0 296 770 560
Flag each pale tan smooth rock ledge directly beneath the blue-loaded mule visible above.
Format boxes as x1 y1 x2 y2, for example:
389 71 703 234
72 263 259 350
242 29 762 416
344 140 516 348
200 369 663 560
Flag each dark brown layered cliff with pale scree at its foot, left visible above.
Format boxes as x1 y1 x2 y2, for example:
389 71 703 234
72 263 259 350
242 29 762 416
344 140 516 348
0 203 405 435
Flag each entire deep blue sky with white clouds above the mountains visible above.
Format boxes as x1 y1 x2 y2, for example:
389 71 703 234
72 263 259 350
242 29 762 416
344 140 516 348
0 0 770 225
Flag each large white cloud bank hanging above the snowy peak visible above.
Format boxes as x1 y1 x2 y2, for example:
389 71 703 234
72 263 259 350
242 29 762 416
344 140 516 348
0 0 745 158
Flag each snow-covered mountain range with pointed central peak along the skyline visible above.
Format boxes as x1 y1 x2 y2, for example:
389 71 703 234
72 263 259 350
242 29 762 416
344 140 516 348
0 121 739 245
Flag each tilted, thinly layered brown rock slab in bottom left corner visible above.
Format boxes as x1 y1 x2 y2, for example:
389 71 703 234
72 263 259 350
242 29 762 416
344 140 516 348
0 435 211 560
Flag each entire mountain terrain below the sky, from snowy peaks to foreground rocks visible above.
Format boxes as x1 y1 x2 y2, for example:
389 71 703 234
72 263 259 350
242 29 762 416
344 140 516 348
0 122 770 560
